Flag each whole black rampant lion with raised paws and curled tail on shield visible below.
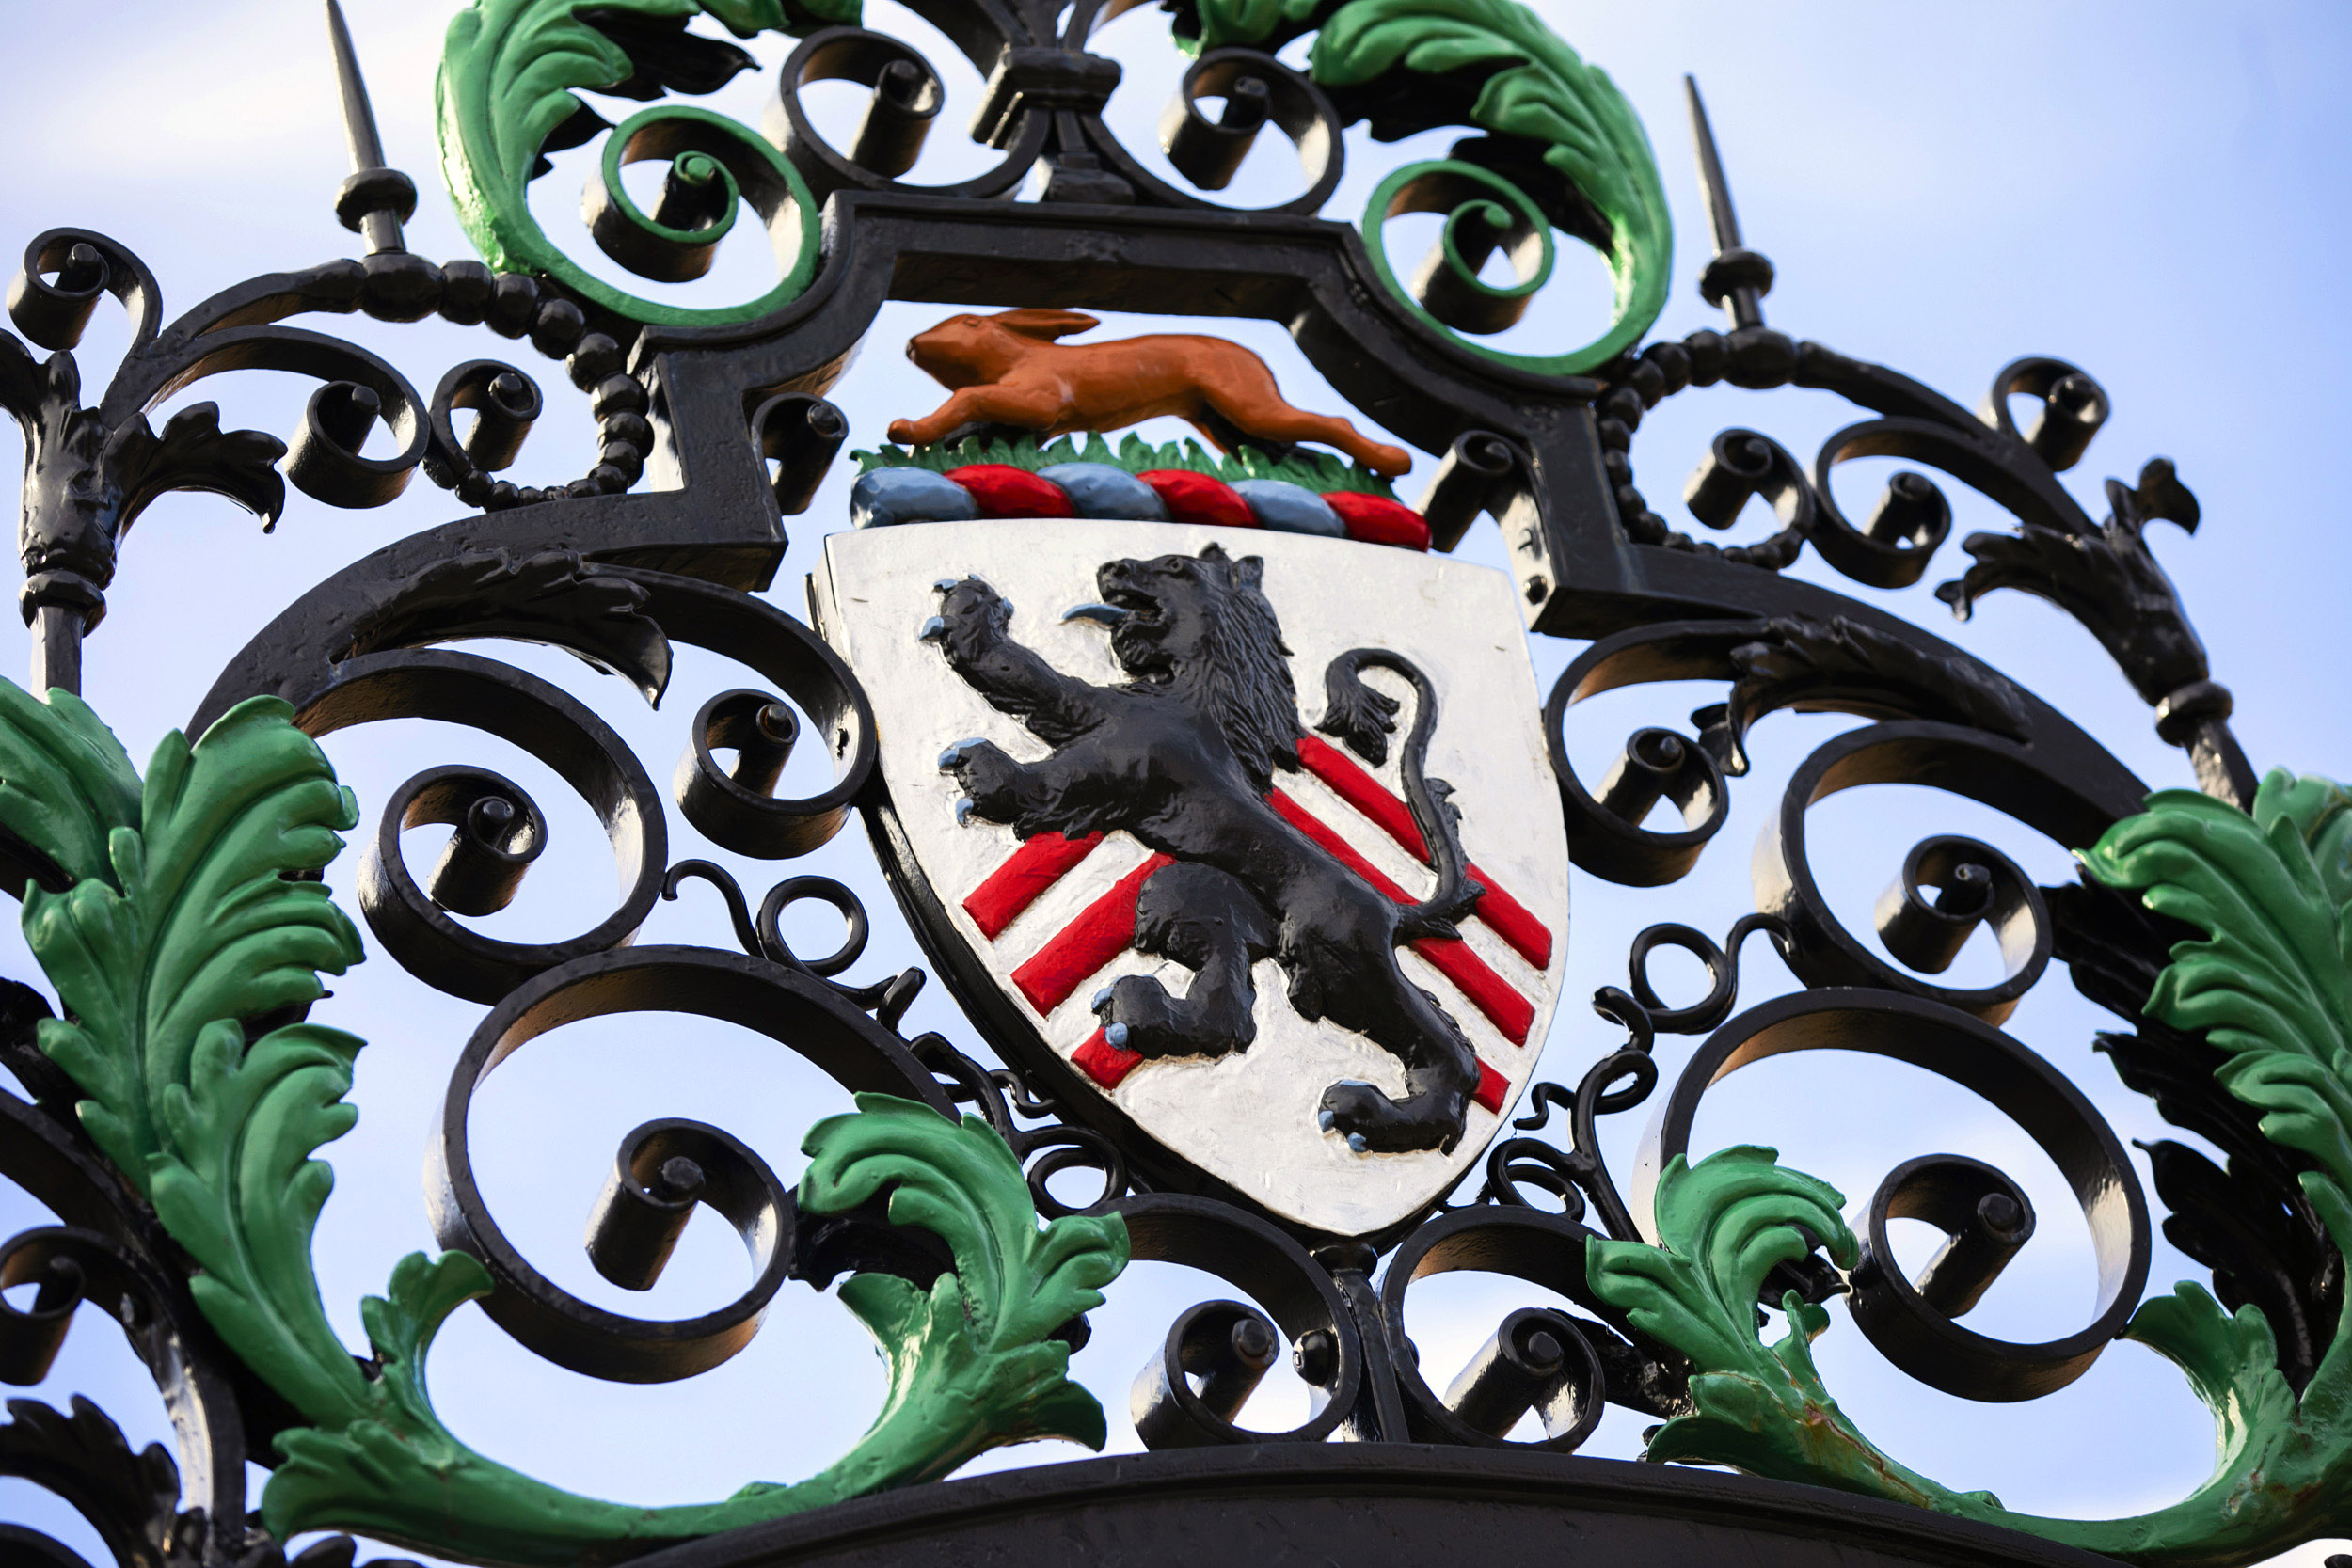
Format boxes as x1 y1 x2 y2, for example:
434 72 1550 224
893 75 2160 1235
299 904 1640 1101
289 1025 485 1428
922 546 1485 1152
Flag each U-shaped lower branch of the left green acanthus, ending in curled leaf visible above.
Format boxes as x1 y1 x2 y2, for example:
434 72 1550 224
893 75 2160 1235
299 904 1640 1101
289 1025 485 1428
263 1096 1127 1563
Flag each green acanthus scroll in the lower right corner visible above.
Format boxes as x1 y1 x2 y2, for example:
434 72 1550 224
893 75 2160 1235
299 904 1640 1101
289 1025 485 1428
1590 771 2352 1568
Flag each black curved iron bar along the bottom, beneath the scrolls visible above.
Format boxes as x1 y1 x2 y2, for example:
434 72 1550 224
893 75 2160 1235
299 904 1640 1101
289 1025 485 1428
633 1444 2110 1568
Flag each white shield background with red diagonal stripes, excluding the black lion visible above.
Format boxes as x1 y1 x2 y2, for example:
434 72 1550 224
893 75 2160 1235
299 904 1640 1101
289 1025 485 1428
812 519 1569 1237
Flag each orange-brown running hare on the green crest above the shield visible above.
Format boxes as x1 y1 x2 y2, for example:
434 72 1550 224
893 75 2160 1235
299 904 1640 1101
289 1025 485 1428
889 310 1414 477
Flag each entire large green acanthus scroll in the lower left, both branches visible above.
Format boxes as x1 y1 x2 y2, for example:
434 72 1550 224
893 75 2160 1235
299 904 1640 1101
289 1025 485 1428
0 682 1127 1563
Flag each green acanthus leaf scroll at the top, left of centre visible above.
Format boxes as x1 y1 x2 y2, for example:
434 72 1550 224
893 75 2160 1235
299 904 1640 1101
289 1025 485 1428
436 0 859 326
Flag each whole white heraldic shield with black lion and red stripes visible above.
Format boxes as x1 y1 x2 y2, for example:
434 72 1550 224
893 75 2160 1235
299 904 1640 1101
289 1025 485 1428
812 519 1569 1237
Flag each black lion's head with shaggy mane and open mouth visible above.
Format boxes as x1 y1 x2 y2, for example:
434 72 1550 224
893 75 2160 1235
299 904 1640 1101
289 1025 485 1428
1094 546 1303 792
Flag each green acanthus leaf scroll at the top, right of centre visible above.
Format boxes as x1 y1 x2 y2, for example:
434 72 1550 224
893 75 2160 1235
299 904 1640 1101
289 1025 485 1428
1185 0 1675 376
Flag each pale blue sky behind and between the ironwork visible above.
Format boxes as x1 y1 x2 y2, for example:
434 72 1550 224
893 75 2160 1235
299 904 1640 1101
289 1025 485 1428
0 0 2352 1561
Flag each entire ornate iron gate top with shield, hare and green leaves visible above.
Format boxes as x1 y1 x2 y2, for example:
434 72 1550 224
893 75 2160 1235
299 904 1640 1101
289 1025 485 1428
0 0 2352 1568
